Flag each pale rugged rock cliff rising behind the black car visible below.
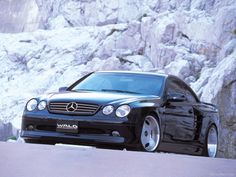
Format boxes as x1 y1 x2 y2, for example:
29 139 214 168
0 0 236 158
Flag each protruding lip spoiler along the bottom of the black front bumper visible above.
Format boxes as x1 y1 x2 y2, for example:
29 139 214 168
21 130 125 144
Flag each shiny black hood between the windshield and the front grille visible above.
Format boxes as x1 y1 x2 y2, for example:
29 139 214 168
43 91 159 105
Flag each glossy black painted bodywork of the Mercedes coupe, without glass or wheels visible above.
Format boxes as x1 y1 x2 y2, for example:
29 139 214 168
21 72 219 155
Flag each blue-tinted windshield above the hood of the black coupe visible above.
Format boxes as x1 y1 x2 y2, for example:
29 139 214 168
71 73 164 96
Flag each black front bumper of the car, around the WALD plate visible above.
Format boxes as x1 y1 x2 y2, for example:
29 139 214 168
21 115 137 146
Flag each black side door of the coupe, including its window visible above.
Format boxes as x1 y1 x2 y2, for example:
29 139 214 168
163 78 195 142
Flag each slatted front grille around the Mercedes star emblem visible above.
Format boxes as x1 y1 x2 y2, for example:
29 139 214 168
49 102 99 115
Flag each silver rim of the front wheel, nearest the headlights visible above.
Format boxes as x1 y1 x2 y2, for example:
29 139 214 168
141 116 160 152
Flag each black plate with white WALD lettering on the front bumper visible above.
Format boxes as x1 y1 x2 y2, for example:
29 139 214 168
56 120 79 133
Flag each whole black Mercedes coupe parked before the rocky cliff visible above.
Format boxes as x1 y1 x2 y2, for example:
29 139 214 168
21 71 219 157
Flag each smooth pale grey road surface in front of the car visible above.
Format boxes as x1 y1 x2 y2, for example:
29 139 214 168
0 142 236 177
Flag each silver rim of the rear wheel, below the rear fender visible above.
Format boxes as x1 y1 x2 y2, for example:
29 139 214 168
207 126 218 157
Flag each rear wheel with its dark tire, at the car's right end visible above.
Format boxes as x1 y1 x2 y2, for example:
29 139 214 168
202 125 218 158
